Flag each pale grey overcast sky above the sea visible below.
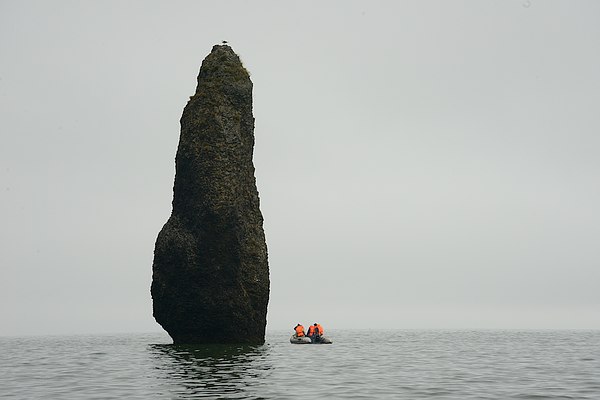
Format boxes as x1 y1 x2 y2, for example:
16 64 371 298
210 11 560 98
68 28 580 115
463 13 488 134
0 0 600 336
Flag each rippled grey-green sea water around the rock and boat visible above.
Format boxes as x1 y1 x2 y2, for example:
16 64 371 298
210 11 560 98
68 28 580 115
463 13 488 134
0 327 600 399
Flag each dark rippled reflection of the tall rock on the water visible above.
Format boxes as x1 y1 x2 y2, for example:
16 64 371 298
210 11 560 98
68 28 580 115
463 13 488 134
149 344 271 399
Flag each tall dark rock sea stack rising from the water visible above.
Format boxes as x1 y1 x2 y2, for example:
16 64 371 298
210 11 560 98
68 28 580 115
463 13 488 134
151 45 269 344
